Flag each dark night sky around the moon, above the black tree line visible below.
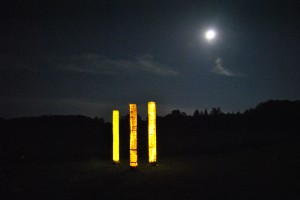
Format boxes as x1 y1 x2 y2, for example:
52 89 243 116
0 0 300 121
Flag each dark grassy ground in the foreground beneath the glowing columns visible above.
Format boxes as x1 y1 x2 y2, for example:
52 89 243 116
1 141 300 200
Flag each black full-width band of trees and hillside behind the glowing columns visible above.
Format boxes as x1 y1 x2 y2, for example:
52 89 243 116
0 101 300 162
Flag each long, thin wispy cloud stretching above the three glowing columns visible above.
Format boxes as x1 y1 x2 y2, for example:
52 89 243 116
59 54 179 76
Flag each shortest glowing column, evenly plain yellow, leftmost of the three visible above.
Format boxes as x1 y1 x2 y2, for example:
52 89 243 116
112 110 120 164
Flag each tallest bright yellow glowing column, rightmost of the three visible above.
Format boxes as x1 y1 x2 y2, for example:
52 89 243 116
148 101 156 165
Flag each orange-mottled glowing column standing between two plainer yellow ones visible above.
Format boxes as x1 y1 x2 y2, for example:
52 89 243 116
129 104 138 169
